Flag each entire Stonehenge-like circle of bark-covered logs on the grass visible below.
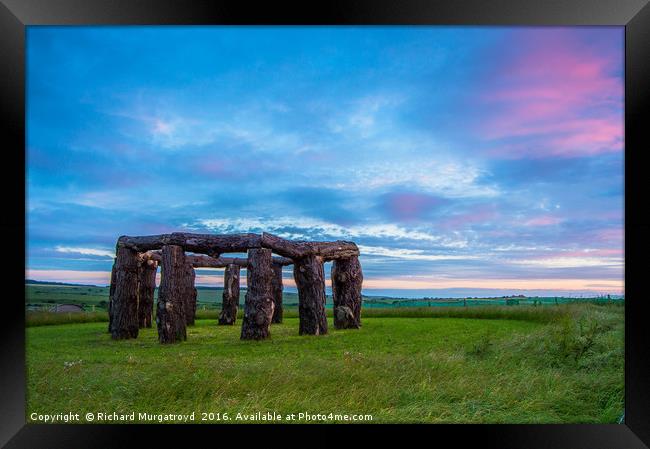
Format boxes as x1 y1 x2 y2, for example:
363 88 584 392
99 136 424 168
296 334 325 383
108 232 363 343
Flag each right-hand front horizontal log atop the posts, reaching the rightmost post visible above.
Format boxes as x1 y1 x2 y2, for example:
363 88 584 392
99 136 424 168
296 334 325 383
261 232 359 260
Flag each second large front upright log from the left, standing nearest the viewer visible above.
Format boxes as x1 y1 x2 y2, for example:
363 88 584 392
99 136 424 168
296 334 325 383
156 245 187 343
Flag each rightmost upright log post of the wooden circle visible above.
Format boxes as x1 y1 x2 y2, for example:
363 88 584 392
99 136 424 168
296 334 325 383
332 256 363 329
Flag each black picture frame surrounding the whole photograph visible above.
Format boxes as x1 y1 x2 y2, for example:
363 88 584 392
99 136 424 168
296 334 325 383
0 0 650 449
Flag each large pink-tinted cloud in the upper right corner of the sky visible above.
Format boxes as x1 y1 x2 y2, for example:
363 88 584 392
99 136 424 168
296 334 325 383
479 30 624 157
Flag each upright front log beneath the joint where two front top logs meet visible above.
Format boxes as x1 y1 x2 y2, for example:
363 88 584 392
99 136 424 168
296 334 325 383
241 248 274 340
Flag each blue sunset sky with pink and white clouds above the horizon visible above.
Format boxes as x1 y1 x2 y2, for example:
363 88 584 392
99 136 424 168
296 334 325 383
25 26 624 297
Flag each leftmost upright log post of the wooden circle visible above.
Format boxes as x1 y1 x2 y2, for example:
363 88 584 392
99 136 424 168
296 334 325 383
110 247 139 340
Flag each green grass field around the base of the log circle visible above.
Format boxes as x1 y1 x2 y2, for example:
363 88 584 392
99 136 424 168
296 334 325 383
26 304 624 423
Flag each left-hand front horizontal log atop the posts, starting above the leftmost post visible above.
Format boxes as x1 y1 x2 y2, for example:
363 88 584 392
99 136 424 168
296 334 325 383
117 232 260 257
